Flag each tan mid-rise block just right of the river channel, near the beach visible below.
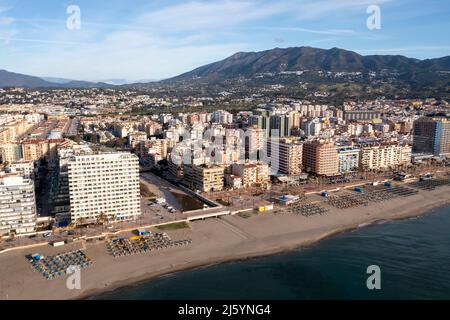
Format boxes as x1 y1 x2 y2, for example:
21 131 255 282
184 164 225 192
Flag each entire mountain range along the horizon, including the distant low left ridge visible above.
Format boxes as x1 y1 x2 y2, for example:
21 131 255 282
0 47 450 91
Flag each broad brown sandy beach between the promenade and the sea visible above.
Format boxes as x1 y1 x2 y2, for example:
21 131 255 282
0 186 450 299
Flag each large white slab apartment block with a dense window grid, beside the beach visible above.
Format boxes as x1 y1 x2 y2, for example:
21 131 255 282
68 152 141 223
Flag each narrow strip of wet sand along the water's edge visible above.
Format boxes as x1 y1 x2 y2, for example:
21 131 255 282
81 199 450 300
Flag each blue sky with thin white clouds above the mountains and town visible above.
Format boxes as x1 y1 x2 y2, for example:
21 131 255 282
0 0 450 81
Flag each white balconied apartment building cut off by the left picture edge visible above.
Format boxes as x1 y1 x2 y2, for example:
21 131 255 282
0 174 37 236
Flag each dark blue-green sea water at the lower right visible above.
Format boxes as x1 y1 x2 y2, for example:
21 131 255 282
94 207 450 300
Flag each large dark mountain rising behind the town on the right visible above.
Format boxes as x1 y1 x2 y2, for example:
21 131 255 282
165 47 450 83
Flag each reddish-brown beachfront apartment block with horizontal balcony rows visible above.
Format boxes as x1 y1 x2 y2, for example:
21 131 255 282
303 139 339 176
